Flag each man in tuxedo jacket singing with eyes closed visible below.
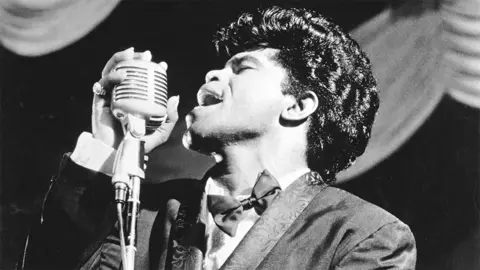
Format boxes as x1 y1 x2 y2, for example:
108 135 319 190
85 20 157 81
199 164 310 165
22 4 416 269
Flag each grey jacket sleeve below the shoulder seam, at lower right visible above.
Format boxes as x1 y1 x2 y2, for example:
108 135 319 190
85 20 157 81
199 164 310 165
334 221 416 270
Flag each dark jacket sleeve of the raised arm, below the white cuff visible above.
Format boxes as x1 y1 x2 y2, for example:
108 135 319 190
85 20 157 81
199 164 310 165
18 154 115 270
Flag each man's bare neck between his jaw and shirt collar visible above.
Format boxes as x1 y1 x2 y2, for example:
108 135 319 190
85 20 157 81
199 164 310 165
210 129 307 196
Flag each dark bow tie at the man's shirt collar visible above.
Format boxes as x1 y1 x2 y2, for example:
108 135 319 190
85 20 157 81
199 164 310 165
207 170 280 237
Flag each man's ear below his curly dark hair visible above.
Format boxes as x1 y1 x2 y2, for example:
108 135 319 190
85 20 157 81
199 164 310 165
280 91 318 121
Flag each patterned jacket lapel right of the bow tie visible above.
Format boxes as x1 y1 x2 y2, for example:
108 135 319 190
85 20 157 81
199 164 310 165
221 172 326 270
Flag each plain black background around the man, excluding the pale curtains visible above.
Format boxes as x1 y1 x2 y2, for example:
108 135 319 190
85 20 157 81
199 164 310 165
0 1 480 269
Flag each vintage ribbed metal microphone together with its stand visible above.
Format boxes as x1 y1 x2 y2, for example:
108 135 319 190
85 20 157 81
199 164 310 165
111 59 168 270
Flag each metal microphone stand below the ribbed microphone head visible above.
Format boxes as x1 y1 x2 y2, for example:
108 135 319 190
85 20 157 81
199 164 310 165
112 114 145 270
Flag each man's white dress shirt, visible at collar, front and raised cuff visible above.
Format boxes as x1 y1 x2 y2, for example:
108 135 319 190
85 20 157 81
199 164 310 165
70 132 310 270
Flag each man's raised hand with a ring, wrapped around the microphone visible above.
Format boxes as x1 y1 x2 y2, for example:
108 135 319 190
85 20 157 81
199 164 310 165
92 48 179 153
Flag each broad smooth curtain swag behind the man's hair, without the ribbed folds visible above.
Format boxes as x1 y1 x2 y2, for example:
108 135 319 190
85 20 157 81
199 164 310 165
338 6 451 182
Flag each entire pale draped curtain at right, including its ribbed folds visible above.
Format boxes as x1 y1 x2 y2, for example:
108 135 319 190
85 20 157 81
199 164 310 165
338 0 480 181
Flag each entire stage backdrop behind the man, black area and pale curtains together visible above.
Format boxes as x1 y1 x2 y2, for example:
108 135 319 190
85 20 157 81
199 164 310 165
0 0 480 269
